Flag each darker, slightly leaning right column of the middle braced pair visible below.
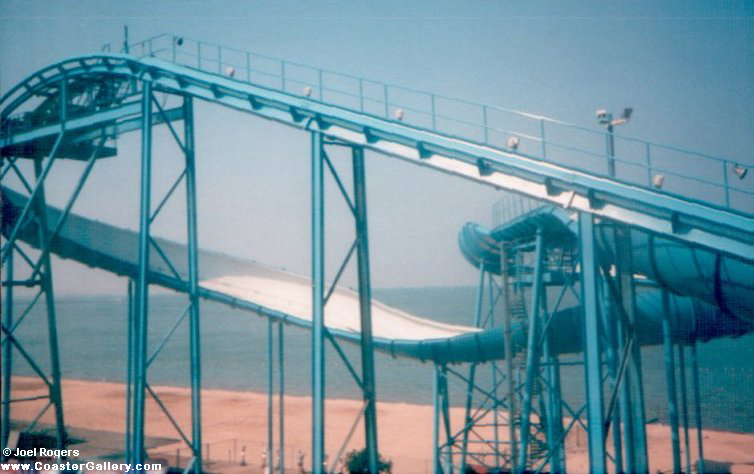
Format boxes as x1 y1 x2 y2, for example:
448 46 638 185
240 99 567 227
353 147 379 473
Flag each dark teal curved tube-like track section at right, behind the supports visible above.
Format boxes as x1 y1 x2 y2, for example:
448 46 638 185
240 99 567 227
458 206 754 340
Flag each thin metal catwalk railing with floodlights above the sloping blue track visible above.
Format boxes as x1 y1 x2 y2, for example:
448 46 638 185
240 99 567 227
102 34 754 215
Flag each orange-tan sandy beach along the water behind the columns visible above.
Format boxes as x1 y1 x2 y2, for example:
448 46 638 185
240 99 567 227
5 377 754 474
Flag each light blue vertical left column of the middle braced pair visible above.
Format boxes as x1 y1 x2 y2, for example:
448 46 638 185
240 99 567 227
312 132 325 474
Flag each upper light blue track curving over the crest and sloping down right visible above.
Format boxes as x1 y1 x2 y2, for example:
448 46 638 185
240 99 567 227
0 55 754 259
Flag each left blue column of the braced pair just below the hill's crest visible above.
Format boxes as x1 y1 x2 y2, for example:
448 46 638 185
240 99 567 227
132 81 152 464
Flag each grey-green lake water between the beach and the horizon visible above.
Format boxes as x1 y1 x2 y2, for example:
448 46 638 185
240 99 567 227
7 287 754 432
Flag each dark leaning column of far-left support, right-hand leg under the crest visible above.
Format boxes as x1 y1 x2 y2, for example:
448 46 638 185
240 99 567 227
32 159 68 449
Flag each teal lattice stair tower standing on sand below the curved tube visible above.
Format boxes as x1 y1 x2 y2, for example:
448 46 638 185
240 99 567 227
433 229 587 473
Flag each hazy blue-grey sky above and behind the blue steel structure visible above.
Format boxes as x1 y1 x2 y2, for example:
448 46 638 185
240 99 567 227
0 0 754 293
